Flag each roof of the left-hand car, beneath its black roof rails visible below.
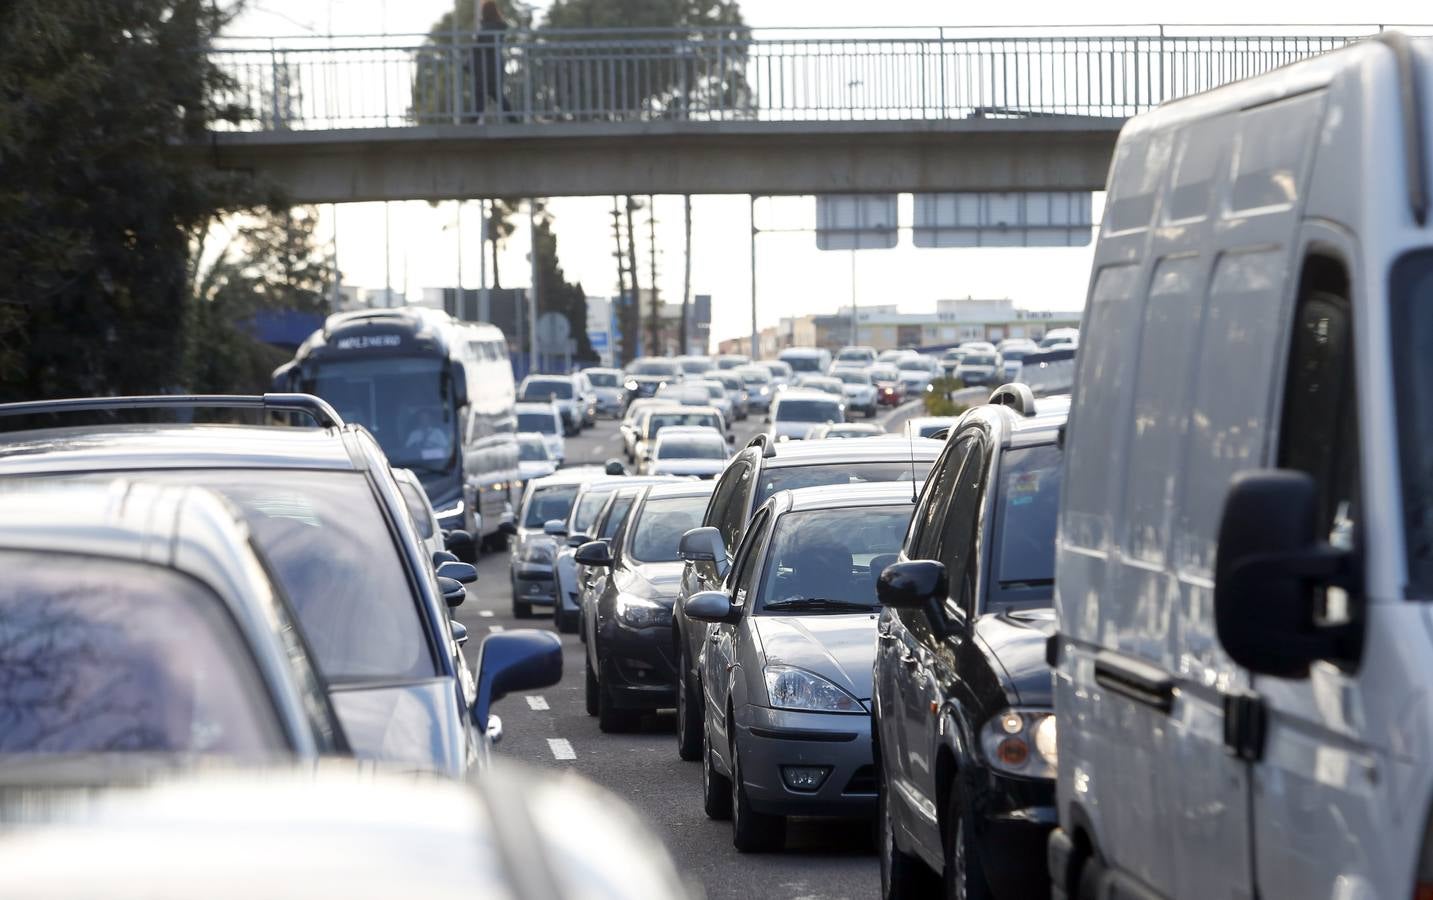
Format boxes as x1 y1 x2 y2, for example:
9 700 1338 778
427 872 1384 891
0 424 363 476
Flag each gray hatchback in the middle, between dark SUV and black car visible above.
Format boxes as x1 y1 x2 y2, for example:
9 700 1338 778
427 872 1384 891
682 484 913 851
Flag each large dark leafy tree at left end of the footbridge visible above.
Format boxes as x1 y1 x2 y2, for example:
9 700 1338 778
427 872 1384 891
0 0 269 400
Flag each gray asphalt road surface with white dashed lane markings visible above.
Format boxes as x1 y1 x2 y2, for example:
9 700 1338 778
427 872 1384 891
457 392 974 900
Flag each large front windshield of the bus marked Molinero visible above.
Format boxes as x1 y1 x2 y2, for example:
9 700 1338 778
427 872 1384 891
308 357 457 471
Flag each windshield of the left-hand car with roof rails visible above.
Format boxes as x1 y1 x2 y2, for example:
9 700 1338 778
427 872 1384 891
145 469 437 681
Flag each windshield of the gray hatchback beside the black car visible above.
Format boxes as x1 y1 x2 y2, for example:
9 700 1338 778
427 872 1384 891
757 503 914 615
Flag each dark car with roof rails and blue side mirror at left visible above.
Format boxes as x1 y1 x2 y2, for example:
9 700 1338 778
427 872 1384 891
0 394 562 775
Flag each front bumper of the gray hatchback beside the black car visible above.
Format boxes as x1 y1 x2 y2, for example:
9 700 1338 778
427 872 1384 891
737 705 876 818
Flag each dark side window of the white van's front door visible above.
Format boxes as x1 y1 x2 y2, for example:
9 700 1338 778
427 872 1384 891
1278 270 1358 546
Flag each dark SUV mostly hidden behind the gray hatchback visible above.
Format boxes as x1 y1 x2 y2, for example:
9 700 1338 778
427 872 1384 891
672 434 941 760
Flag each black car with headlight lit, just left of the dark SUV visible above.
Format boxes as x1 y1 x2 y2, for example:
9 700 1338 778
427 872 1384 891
577 482 712 731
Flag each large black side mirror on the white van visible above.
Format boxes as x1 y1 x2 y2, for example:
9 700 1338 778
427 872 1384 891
1214 469 1363 678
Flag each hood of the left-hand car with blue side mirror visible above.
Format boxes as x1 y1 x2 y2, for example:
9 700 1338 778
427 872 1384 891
330 678 464 775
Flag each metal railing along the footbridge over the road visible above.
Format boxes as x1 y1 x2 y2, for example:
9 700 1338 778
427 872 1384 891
211 26 1410 130
